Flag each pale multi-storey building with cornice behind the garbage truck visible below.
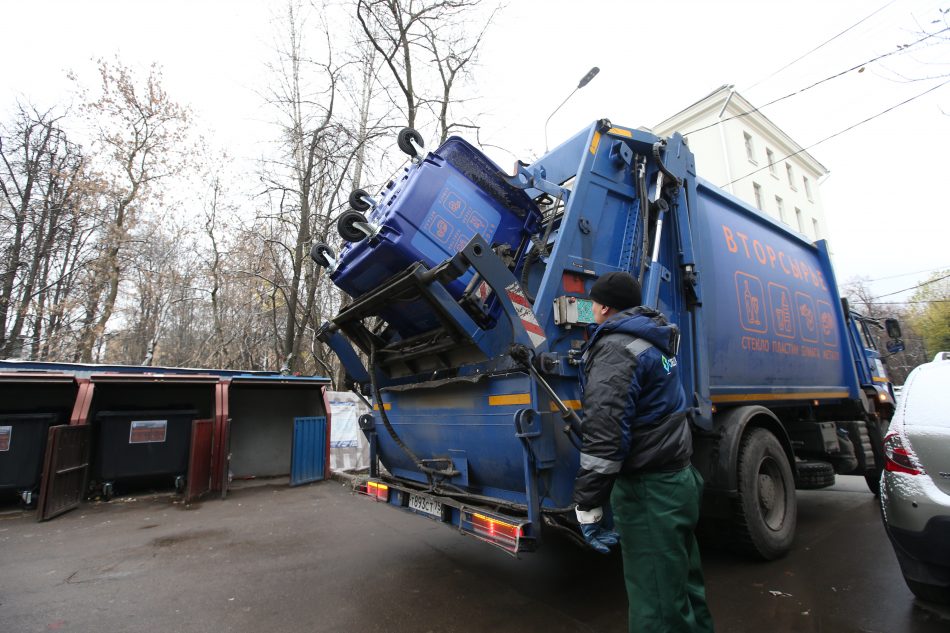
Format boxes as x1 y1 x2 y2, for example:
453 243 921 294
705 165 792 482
653 85 829 240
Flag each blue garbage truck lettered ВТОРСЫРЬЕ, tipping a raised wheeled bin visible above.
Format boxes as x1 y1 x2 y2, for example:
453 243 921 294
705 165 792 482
311 119 901 559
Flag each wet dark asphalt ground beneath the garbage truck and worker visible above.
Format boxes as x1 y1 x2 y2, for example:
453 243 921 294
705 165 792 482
0 477 950 633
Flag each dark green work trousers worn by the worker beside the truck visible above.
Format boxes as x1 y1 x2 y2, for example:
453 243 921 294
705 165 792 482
610 466 713 633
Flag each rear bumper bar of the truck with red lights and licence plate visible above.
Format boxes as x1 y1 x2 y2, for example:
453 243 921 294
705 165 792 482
354 479 539 556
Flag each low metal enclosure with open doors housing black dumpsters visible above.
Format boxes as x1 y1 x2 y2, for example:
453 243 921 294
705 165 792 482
0 361 330 518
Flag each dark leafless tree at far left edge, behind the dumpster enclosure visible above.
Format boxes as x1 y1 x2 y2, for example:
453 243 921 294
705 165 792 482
0 105 99 358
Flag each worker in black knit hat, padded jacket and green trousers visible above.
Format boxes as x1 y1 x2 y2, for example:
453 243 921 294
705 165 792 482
574 272 713 633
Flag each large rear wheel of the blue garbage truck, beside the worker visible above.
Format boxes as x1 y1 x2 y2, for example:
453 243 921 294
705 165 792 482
734 428 798 560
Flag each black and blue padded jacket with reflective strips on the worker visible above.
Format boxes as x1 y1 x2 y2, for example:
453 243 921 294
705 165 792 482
574 307 692 510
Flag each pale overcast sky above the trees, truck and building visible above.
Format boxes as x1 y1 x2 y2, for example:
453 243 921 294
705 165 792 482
0 0 950 300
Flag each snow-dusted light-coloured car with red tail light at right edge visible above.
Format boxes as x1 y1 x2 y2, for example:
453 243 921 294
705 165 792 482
881 352 950 603
